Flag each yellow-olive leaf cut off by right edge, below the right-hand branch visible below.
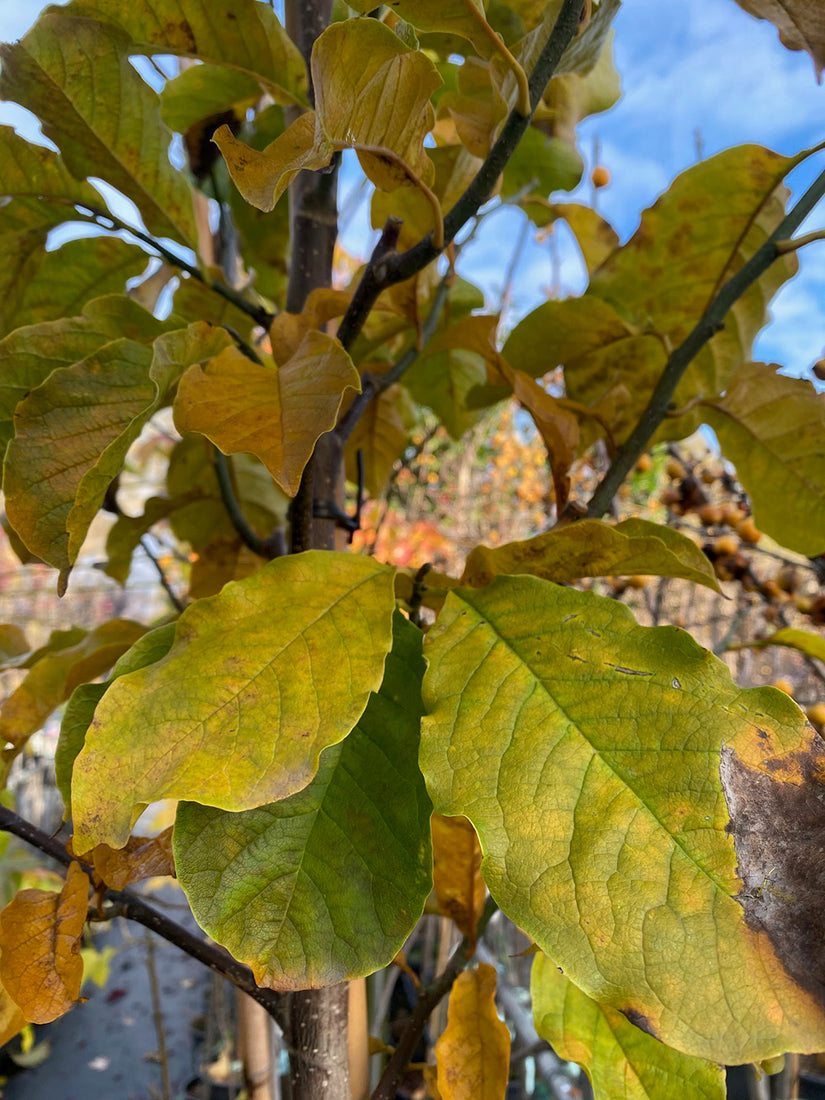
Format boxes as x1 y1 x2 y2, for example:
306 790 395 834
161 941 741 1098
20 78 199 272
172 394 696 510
703 363 825 556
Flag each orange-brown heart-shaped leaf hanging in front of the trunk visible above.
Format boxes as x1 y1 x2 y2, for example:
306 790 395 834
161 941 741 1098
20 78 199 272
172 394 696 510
175 332 361 496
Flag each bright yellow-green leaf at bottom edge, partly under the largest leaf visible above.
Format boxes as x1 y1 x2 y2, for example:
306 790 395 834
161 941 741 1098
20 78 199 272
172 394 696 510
530 954 726 1100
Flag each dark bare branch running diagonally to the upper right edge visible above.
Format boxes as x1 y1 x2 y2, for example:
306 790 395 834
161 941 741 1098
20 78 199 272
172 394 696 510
587 163 825 519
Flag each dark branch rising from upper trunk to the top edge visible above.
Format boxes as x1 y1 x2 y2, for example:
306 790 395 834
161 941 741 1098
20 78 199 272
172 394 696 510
338 0 585 349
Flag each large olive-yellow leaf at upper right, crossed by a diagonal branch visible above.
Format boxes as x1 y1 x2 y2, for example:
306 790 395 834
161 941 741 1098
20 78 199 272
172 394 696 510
504 145 796 440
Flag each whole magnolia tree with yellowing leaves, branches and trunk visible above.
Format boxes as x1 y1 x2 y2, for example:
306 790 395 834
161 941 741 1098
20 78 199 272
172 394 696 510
0 0 825 1098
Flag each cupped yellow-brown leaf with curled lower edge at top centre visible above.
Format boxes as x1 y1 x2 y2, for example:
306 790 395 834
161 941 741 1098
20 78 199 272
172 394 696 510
312 19 441 190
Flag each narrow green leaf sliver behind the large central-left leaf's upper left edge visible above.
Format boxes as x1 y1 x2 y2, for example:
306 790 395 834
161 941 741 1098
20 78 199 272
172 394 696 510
54 623 175 821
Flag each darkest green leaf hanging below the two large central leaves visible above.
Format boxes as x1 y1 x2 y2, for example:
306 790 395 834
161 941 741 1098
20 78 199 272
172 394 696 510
175 613 432 989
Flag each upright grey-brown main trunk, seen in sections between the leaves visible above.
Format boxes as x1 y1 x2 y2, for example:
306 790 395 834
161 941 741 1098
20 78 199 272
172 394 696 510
282 0 350 1100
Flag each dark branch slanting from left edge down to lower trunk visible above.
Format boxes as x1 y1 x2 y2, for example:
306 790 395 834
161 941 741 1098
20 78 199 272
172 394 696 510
0 806 281 1018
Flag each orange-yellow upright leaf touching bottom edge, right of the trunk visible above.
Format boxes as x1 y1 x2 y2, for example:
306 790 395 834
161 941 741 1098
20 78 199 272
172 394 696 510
436 963 510 1100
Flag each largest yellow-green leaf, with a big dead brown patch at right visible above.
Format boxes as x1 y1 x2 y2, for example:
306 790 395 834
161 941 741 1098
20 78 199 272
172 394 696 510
421 576 825 1063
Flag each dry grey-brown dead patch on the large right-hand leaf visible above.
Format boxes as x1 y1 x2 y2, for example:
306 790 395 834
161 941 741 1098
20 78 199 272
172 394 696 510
719 732 825 1003
